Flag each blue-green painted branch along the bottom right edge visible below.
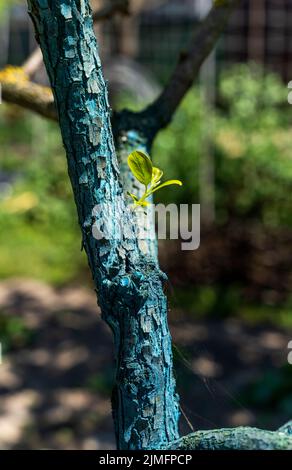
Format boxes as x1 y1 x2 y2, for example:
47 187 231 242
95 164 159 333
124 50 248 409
169 421 292 450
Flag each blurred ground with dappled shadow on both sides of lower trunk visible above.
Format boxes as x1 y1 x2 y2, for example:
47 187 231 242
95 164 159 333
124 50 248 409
0 280 292 449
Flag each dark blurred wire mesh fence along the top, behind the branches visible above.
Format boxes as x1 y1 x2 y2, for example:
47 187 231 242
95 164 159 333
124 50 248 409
0 0 292 83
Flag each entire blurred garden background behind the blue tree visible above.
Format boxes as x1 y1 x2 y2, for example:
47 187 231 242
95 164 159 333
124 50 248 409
0 0 292 449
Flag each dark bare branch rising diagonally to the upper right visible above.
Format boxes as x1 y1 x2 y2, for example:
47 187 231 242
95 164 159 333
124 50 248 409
117 0 240 139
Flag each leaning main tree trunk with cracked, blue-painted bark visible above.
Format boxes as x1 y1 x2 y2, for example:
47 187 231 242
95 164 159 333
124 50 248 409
28 0 179 449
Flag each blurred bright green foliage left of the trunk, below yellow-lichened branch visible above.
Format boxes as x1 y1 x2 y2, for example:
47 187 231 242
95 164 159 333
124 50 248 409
0 105 85 284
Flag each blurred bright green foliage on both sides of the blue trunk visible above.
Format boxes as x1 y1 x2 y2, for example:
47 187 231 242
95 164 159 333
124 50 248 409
0 65 292 296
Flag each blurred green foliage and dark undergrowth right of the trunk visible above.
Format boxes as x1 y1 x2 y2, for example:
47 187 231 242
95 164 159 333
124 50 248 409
153 64 292 327
